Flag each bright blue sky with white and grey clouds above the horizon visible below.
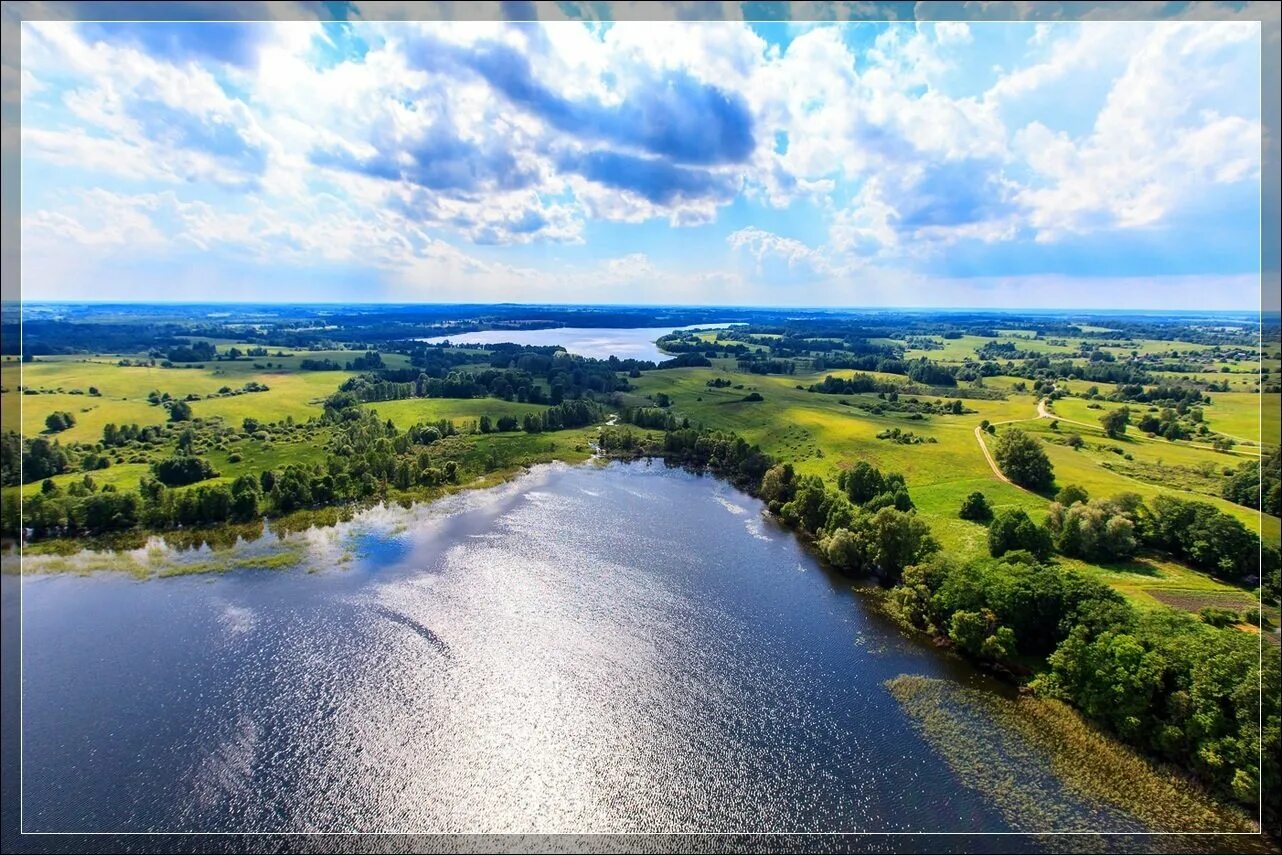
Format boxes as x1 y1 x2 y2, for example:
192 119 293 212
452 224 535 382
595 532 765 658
12 21 1261 309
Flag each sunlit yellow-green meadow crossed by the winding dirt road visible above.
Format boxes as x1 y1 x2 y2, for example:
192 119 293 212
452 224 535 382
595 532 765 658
628 368 1279 604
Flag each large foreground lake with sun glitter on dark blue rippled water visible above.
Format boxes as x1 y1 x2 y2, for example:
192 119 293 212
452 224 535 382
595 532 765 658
5 463 1189 849
